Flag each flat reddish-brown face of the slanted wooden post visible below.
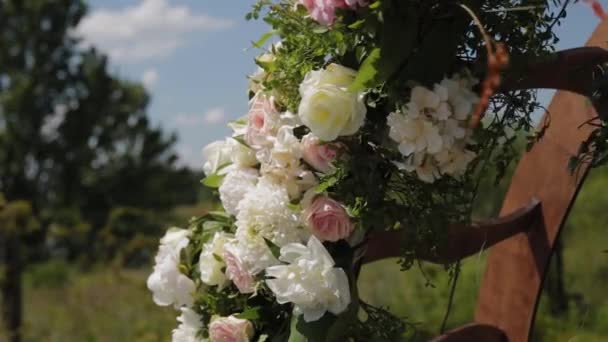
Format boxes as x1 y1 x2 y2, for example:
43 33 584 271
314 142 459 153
475 21 608 342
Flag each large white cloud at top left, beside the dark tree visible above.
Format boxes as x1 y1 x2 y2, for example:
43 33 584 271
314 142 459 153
77 0 233 62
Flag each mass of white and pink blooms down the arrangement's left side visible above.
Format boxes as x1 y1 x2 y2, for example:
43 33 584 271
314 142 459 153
148 64 366 341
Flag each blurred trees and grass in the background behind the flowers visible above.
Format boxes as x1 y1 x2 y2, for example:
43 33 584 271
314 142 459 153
0 0 608 341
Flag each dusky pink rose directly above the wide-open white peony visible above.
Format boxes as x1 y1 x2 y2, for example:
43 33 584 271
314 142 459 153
304 195 355 242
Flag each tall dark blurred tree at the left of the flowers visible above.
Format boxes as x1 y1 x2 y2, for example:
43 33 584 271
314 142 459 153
0 0 197 341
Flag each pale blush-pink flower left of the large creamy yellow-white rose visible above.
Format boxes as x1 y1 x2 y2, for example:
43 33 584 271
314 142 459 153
245 95 277 147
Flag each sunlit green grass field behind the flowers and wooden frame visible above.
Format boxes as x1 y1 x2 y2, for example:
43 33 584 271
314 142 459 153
0 170 608 342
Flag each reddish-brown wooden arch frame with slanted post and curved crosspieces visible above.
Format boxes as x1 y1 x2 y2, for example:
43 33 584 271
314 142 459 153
365 20 608 342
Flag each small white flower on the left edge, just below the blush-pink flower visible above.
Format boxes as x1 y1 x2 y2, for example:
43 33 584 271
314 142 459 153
203 138 257 175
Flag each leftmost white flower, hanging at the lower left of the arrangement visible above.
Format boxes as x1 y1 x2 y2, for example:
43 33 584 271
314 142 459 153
147 228 195 308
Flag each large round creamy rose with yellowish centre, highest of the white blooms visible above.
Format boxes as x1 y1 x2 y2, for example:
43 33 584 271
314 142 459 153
298 64 367 141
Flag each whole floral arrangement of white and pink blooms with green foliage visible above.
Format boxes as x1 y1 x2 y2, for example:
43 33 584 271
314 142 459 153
148 0 576 342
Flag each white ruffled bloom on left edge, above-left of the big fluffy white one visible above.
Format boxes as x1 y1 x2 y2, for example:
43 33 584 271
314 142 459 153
218 168 259 216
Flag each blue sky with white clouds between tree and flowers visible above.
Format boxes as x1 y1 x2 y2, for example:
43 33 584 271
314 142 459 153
79 0 608 168
